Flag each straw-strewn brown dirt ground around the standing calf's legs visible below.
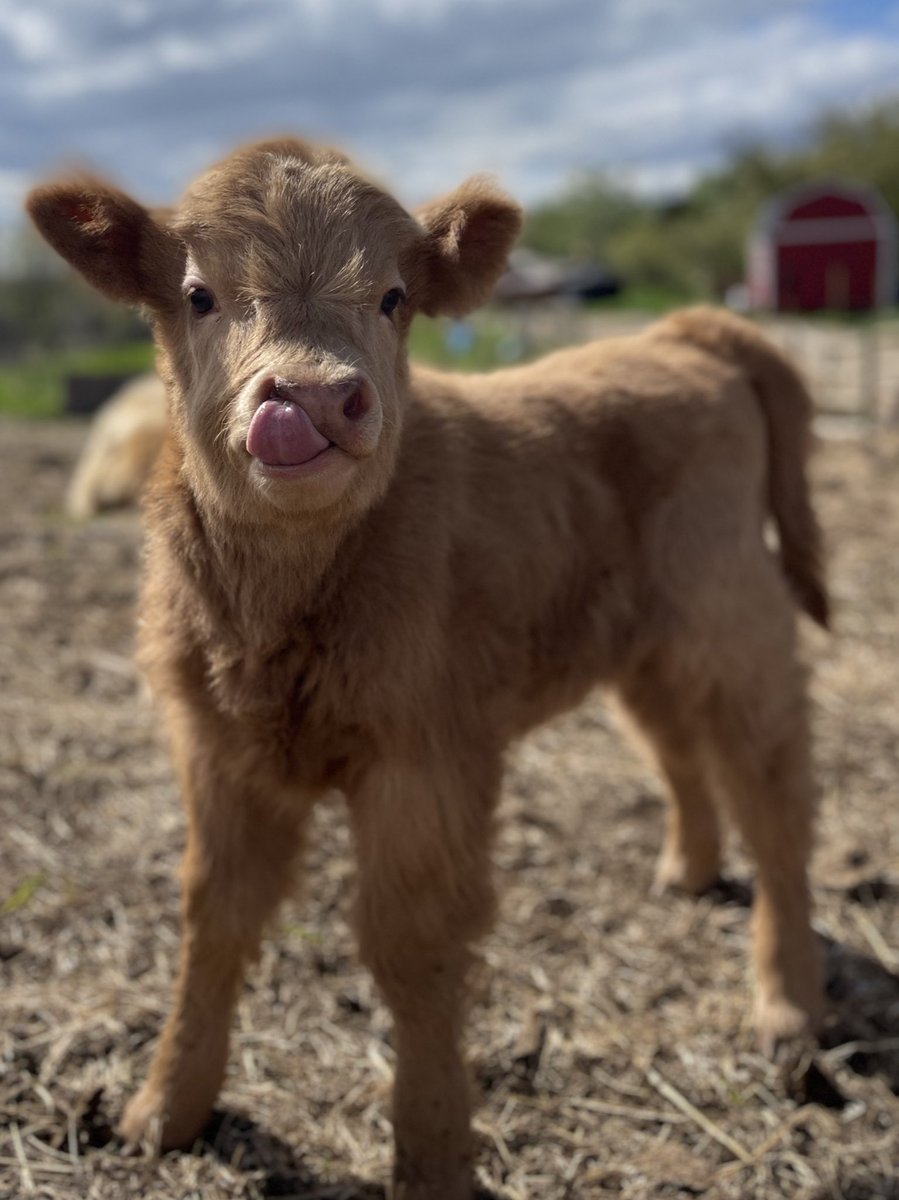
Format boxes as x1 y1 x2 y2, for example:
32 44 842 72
0 424 899 1200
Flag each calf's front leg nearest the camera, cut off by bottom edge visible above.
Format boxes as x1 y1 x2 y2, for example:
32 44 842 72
350 766 498 1200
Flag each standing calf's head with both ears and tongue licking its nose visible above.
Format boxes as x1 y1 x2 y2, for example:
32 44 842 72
28 139 521 523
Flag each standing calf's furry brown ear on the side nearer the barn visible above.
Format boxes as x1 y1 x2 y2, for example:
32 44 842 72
415 176 522 317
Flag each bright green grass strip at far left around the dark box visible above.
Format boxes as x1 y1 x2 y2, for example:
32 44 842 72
0 342 154 418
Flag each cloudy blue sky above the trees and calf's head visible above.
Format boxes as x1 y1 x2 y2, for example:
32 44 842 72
0 0 899 237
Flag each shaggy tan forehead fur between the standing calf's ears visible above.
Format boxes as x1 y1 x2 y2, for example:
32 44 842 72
174 143 422 304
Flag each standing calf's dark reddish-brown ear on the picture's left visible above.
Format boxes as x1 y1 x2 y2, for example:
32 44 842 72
25 179 185 310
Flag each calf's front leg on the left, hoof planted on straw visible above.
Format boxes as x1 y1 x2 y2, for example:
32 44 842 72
121 728 307 1150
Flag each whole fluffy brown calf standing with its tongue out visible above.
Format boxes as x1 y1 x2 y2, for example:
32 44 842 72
30 140 826 1200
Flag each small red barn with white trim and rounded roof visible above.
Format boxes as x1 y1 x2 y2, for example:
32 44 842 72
749 180 897 312
